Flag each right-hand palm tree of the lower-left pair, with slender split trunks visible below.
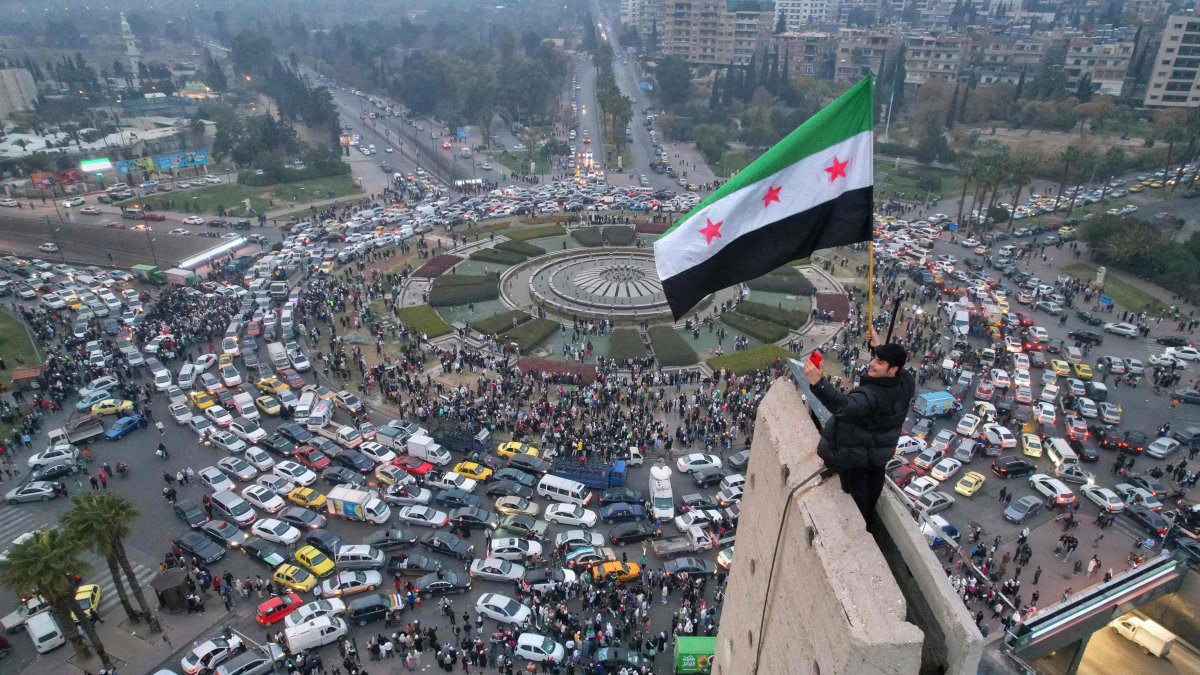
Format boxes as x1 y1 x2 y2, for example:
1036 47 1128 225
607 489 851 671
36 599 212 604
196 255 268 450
62 492 162 633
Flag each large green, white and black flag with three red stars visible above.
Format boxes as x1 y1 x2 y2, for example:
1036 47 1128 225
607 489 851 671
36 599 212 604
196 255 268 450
654 77 874 321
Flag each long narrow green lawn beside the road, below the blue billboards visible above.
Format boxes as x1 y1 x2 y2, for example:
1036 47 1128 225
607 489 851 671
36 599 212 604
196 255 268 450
121 175 359 217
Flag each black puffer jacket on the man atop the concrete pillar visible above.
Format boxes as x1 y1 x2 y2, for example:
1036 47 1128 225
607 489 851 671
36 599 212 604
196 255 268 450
812 369 917 468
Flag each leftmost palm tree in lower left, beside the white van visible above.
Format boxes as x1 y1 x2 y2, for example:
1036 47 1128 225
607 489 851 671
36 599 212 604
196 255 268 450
0 527 113 668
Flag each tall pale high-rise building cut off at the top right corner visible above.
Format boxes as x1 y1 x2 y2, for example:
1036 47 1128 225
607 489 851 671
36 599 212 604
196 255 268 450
1145 14 1200 108
